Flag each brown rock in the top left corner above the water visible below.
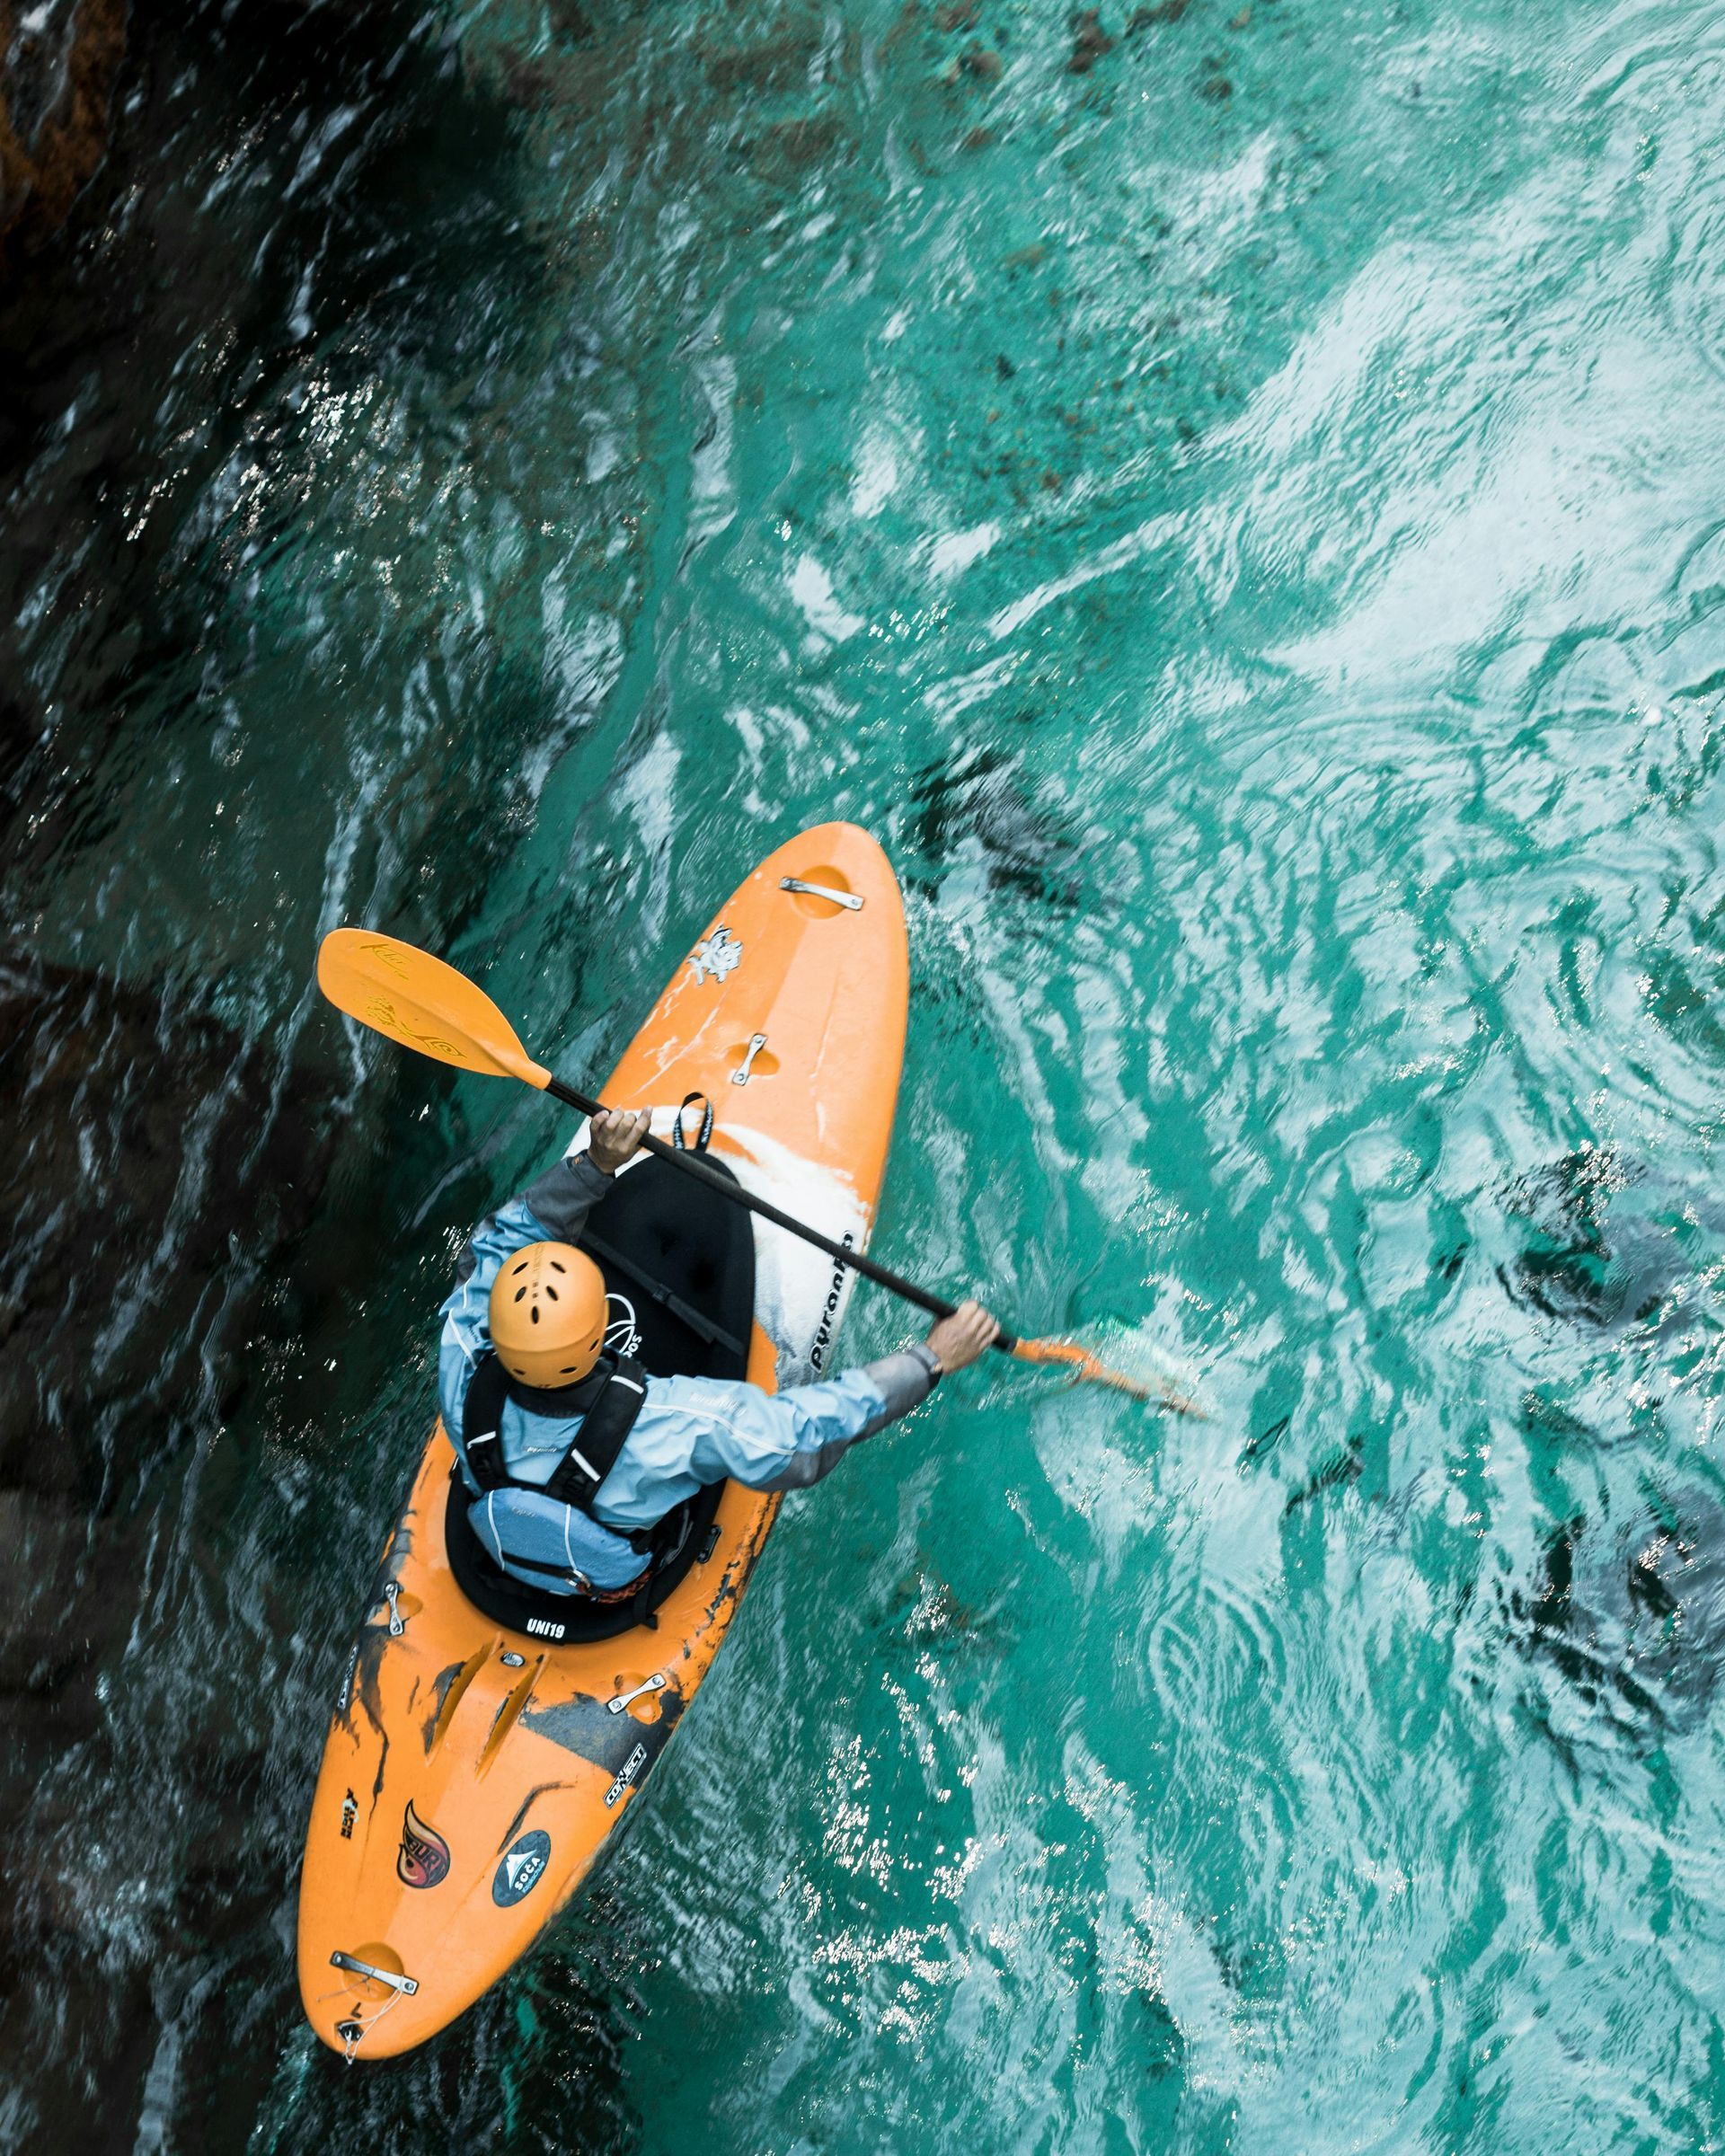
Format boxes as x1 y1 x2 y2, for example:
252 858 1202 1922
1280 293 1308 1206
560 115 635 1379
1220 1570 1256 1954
0 0 125 278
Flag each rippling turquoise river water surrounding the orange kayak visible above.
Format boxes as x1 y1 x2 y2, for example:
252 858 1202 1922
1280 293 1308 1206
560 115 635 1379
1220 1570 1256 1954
0 0 1725 2156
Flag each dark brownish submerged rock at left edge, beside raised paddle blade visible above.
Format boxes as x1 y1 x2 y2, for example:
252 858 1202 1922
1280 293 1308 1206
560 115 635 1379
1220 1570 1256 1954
0 935 332 1707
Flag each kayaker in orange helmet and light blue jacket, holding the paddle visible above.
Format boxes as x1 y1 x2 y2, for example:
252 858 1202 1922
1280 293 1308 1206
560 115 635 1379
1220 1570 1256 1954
438 1109 1001 1600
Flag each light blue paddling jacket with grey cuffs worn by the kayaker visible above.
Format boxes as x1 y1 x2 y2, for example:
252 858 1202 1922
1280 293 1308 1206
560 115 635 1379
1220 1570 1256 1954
438 1153 940 1594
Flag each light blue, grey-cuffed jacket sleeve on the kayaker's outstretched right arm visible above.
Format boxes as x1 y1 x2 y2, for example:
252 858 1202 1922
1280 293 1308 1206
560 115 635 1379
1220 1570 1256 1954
653 1348 936 1489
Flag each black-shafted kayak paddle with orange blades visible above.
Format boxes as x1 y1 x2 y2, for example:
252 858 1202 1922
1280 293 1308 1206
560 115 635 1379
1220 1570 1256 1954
317 929 1201 1414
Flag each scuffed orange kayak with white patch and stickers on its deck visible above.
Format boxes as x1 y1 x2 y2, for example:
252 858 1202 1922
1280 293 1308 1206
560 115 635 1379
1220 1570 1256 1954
300 824 907 2059
